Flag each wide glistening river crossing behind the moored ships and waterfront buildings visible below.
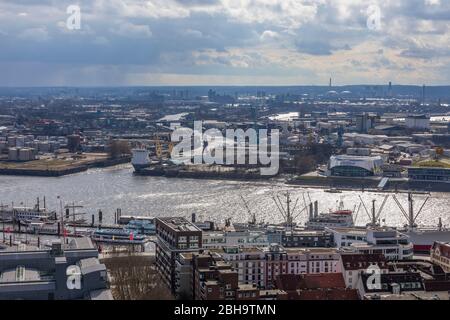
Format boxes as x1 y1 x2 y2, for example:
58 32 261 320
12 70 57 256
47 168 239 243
0 165 450 226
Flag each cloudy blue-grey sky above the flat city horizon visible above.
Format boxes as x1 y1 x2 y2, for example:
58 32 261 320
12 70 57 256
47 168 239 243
0 0 450 86
